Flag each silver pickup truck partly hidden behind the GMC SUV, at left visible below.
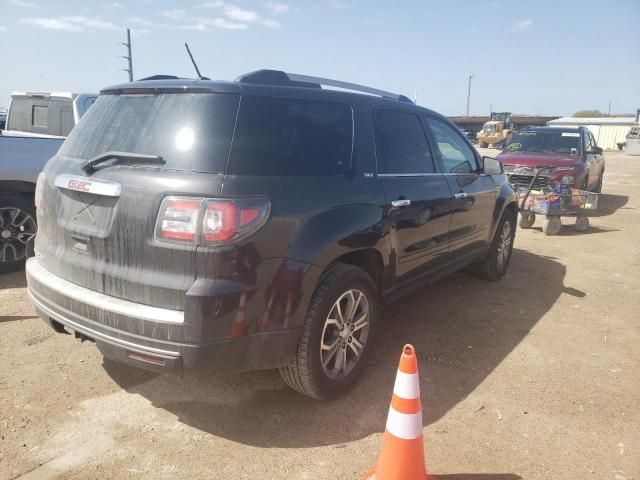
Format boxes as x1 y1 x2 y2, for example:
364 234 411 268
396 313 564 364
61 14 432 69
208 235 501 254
0 92 97 273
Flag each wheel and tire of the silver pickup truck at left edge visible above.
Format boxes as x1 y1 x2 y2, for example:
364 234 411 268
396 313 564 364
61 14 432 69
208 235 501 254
0 194 38 273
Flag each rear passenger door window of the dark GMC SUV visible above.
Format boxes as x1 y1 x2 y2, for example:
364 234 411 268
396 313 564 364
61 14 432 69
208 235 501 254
374 109 434 174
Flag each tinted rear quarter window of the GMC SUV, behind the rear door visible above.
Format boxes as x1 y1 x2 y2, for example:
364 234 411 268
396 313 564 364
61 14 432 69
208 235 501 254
227 95 353 176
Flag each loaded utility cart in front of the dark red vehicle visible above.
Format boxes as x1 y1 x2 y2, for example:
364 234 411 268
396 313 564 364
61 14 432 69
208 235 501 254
516 166 599 235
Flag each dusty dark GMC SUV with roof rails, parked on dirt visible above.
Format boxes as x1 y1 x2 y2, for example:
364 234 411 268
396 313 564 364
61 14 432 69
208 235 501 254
26 70 517 398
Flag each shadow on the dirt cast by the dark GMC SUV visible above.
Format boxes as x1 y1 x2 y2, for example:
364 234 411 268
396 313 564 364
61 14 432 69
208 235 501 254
104 249 572 452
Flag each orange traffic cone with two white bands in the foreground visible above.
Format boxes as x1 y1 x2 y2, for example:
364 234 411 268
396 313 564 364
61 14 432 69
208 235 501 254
365 345 435 480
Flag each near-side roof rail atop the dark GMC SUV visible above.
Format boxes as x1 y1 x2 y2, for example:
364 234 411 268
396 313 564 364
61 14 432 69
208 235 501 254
236 70 413 103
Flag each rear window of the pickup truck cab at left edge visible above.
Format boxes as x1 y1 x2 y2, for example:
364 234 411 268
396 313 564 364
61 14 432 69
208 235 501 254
7 98 73 137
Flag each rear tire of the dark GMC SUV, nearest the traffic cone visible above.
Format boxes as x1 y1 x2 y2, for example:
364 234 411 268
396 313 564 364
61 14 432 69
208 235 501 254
280 263 378 400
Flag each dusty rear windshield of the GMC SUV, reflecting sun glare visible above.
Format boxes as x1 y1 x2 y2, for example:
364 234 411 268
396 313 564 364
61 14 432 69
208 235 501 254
60 93 240 173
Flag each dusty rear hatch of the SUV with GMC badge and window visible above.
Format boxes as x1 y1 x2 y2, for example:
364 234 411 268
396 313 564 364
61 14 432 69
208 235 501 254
36 89 239 310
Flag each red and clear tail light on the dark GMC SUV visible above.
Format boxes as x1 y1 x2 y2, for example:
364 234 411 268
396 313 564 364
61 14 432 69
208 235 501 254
155 196 270 246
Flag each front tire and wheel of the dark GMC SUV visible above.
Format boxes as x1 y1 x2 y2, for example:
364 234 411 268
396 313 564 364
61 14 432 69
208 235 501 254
471 210 516 282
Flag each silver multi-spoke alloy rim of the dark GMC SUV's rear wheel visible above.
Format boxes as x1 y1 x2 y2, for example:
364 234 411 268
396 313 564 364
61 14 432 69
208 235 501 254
320 289 370 380
